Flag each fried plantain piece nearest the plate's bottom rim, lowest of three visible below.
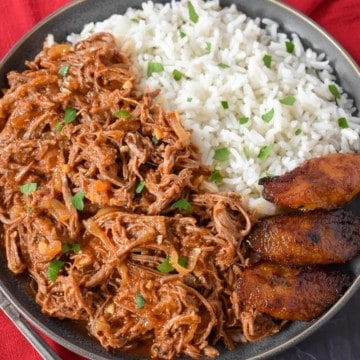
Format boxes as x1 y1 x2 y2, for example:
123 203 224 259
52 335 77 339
235 263 350 321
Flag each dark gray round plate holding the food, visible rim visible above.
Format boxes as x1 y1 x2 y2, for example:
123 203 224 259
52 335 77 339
0 0 360 360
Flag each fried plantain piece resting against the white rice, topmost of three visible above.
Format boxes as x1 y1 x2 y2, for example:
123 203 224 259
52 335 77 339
259 154 360 210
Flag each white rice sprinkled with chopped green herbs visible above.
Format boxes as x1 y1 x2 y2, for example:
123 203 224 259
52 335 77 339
68 0 360 214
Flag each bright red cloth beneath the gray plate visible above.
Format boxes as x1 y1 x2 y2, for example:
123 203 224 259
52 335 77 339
0 0 360 360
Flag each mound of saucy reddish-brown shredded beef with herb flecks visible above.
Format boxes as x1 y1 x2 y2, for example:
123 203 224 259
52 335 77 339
0 33 275 359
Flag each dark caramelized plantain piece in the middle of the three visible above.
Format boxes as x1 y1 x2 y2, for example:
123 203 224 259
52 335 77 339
246 209 360 265
